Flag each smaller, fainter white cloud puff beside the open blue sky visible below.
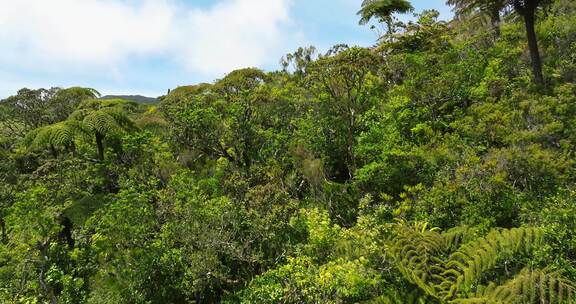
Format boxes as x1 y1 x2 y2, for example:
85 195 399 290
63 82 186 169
175 0 291 73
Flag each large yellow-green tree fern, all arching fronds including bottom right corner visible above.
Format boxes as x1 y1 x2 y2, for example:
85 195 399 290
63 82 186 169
382 223 575 303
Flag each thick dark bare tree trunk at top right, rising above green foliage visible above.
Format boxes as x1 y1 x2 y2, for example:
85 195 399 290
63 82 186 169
520 0 544 85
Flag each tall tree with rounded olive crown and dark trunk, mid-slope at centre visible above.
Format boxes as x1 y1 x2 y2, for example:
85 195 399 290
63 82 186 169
306 45 380 182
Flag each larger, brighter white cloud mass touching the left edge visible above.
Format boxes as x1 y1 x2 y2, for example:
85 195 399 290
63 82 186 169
0 0 173 68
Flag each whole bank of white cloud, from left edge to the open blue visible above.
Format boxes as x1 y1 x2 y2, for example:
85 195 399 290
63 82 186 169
0 0 295 77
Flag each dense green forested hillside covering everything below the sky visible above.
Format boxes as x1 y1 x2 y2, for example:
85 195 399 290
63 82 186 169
0 0 576 304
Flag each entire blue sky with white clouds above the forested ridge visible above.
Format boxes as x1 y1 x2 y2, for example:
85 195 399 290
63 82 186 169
0 0 451 98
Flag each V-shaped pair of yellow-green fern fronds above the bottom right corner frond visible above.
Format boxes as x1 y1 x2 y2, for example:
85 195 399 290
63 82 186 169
388 223 543 303
